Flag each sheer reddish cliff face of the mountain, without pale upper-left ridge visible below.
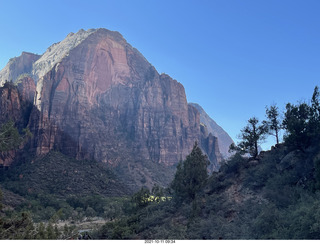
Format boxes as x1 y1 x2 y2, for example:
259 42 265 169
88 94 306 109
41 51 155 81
32 29 208 170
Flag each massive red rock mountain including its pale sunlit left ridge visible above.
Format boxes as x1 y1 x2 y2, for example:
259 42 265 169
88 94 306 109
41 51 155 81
0 29 221 187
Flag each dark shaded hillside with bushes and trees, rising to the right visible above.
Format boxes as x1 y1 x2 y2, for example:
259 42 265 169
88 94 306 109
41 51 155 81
95 87 320 239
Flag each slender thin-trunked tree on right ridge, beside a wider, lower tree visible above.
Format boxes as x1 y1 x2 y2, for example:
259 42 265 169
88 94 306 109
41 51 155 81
263 105 282 144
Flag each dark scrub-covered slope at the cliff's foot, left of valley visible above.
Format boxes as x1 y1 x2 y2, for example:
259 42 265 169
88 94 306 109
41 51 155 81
1 151 132 196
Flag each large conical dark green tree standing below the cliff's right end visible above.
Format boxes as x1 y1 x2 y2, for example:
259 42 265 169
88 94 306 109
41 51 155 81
171 143 210 201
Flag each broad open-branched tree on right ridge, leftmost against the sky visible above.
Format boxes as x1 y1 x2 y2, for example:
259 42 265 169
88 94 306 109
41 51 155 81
230 117 268 158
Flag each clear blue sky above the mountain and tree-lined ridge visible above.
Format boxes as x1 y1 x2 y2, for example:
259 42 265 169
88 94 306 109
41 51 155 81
0 0 320 150
